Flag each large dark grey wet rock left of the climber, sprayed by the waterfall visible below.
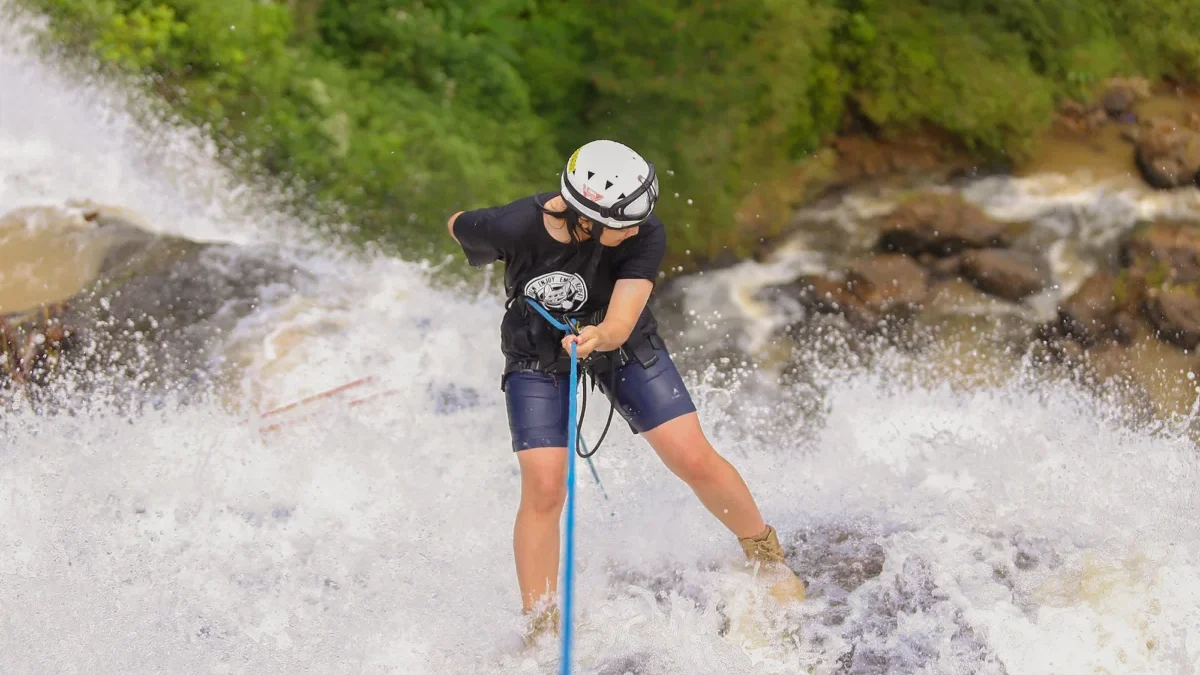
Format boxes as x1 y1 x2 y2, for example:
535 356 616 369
0 199 304 398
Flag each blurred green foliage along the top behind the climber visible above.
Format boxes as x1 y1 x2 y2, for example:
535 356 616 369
24 0 1200 263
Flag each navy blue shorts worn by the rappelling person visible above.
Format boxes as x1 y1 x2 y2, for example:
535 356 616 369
504 350 696 450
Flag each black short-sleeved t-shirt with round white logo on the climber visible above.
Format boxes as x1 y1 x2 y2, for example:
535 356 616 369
454 189 667 364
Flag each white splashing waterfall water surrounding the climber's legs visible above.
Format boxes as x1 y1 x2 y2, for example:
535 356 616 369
0 6 1200 675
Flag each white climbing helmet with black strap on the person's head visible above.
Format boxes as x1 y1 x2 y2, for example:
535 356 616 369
562 141 659 229
